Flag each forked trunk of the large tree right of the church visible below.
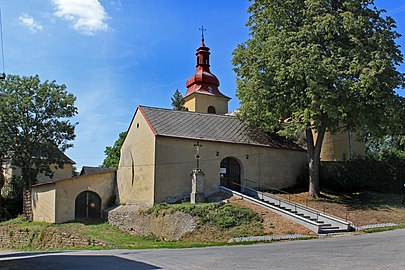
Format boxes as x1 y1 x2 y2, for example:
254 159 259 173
306 122 326 198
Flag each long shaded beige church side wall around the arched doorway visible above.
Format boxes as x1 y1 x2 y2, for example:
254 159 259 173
154 136 306 203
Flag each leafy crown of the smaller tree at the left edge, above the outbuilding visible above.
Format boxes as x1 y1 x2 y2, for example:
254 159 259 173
0 75 77 188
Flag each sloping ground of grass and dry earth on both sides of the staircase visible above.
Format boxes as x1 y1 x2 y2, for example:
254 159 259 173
0 192 405 250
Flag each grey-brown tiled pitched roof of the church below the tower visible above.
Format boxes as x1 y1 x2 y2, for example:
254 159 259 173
139 106 304 151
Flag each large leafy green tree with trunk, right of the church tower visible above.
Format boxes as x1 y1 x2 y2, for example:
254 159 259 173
233 0 404 197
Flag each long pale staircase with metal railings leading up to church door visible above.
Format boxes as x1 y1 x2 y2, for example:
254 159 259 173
220 186 353 234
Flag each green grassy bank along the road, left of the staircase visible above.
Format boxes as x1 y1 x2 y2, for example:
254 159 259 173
0 203 272 250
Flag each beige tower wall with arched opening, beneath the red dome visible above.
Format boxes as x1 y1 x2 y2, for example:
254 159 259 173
184 93 229 114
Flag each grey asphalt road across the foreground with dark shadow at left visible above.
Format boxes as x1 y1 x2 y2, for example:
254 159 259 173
0 229 405 270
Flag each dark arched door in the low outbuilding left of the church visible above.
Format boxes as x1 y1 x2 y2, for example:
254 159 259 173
75 191 101 220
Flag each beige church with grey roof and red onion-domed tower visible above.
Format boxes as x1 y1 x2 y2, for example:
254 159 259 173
117 39 306 207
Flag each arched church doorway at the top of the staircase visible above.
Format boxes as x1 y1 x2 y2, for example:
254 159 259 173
220 157 241 191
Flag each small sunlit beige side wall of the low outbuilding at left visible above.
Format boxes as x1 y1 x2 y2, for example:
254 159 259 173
32 184 56 223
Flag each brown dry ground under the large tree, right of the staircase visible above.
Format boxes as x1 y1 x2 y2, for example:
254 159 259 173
278 192 405 226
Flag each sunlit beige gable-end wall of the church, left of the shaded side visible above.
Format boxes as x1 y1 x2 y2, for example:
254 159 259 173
117 109 155 208
